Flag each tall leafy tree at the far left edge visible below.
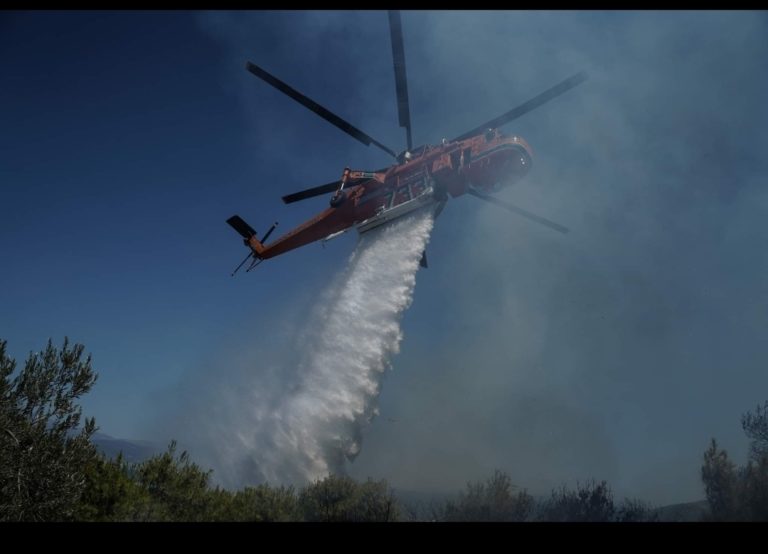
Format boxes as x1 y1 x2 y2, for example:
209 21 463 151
0 338 97 521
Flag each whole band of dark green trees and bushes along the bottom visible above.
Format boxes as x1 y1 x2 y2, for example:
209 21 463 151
21 339 768 522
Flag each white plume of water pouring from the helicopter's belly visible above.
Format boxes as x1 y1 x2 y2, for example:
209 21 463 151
194 207 433 487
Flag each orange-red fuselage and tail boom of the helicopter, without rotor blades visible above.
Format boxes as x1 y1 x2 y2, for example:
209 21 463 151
248 130 533 259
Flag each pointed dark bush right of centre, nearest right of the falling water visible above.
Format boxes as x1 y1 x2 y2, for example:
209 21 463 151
440 470 534 521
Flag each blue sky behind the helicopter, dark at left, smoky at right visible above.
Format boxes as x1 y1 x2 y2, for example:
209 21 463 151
0 11 768 502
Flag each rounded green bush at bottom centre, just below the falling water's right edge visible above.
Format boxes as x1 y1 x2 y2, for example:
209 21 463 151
299 475 399 521
